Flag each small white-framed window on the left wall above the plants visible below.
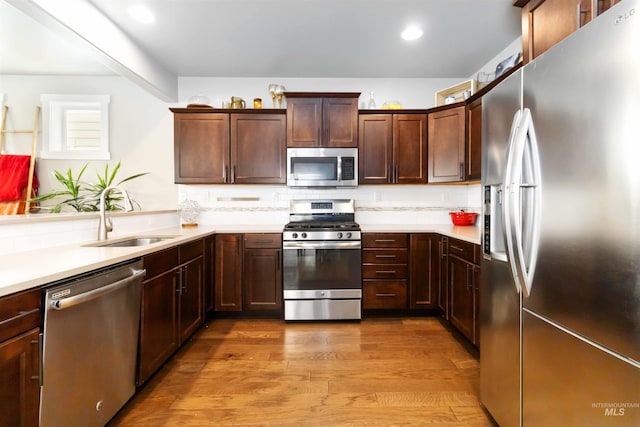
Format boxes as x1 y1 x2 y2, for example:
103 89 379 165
40 95 111 160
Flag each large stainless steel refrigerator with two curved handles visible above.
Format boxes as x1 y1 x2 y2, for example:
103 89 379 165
480 0 640 427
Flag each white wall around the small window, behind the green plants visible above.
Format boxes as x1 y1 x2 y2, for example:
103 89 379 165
0 75 178 210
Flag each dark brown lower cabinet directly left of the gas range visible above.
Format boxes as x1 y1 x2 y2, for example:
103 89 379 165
215 233 282 314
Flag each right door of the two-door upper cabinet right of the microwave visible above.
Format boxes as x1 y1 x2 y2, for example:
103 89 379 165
393 114 427 184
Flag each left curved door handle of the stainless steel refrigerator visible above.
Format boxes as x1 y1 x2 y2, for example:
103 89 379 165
501 110 522 293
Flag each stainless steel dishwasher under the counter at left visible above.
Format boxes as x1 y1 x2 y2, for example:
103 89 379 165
40 261 145 427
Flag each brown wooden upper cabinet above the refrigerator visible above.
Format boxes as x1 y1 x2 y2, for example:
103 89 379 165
514 0 620 63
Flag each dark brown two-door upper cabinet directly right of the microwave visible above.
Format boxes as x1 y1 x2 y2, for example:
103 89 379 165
358 114 427 184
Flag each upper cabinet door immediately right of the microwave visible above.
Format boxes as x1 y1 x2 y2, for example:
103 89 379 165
358 114 393 184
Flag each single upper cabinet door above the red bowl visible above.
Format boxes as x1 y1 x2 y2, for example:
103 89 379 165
428 106 465 182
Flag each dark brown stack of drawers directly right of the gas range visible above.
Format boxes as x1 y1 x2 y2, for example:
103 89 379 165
362 233 409 310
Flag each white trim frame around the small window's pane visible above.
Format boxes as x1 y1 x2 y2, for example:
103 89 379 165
40 94 111 160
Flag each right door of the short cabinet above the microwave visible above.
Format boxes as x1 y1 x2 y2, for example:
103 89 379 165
322 98 358 148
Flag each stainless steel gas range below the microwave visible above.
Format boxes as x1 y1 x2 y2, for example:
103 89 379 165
282 200 362 320
